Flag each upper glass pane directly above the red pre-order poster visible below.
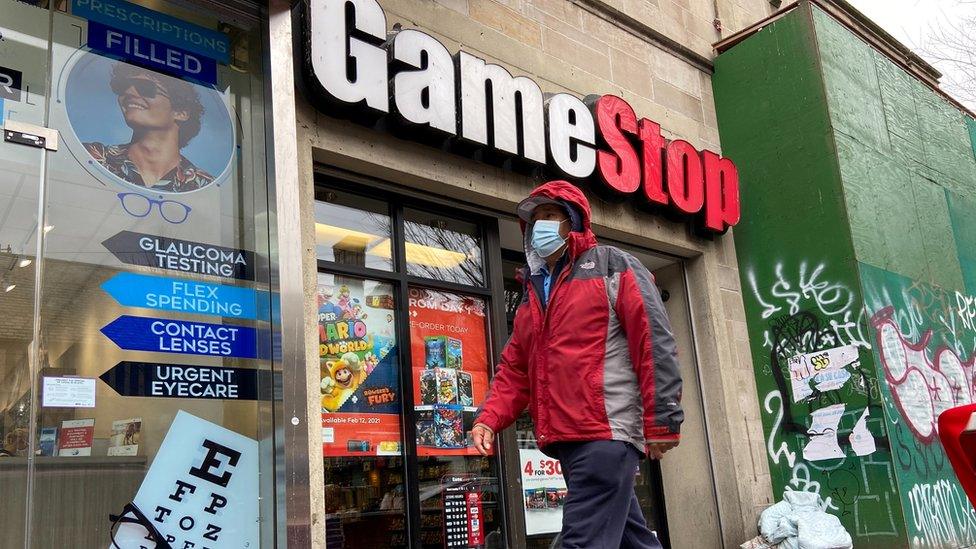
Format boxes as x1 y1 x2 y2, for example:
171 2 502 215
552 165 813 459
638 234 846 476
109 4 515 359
403 209 485 286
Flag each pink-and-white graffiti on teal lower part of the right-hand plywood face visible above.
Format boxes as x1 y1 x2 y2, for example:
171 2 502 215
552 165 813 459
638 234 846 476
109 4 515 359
860 264 976 548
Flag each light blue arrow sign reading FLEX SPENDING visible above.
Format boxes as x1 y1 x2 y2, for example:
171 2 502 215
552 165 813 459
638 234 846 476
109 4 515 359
102 273 257 320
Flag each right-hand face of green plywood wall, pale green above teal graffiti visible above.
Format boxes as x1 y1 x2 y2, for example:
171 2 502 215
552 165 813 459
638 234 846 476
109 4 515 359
813 3 976 548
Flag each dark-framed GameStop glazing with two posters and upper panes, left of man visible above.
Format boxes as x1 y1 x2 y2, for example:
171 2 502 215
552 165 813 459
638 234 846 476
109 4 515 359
316 179 505 548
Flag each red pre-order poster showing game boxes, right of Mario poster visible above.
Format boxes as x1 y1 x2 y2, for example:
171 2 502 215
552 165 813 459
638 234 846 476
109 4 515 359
409 288 488 456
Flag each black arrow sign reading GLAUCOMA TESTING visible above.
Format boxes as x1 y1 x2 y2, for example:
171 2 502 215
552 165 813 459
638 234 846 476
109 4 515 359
102 231 255 280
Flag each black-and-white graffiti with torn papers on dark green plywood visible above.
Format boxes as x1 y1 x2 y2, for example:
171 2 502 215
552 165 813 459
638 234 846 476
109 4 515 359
746 261 900 540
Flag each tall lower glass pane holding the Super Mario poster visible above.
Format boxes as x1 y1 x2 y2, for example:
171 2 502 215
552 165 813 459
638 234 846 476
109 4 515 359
318 274 406 547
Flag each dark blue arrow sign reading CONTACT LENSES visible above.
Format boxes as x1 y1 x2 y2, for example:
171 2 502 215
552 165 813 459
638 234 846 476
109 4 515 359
102 315 263 358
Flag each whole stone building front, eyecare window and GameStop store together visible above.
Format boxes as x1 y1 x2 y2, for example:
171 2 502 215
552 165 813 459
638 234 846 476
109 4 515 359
0 0 771 549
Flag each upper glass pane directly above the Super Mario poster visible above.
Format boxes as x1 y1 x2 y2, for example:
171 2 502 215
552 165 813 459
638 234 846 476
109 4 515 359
315 191 393 271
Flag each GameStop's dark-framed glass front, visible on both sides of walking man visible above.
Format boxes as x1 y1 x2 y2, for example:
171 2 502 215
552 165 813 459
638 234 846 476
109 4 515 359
315 175 690 549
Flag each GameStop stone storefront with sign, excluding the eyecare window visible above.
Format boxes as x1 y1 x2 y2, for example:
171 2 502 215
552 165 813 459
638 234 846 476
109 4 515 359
271 1 771 547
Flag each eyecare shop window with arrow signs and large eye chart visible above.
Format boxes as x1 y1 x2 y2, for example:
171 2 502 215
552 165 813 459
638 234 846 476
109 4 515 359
0 0 278 549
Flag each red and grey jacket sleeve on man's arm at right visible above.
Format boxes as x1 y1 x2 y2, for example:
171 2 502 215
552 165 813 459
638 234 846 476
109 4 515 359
614 251 684 442
